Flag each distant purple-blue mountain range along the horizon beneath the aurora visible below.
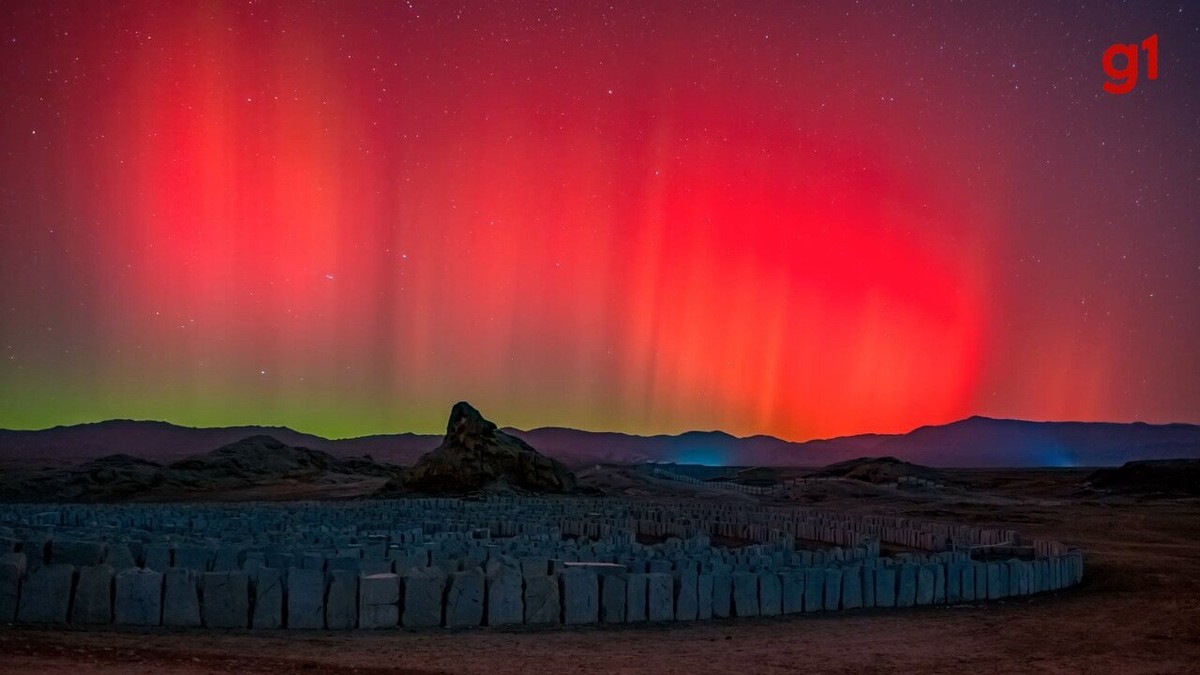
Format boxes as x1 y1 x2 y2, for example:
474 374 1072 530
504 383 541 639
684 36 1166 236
0 417 1200 467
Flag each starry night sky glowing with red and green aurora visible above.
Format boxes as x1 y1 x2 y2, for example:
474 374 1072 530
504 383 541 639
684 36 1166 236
0 0 1200 440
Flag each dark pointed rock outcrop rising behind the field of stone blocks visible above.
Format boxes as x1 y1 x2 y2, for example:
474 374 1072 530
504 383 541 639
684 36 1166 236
384 402 576 495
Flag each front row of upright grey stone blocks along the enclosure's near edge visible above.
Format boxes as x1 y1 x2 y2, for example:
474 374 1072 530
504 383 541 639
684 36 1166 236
0 552 1082 629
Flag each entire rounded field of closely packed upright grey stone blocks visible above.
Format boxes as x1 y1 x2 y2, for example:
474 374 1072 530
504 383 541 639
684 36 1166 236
0 497 1084 629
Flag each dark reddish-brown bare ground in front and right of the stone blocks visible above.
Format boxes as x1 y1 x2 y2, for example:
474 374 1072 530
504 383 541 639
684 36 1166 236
0 472 1200 675
